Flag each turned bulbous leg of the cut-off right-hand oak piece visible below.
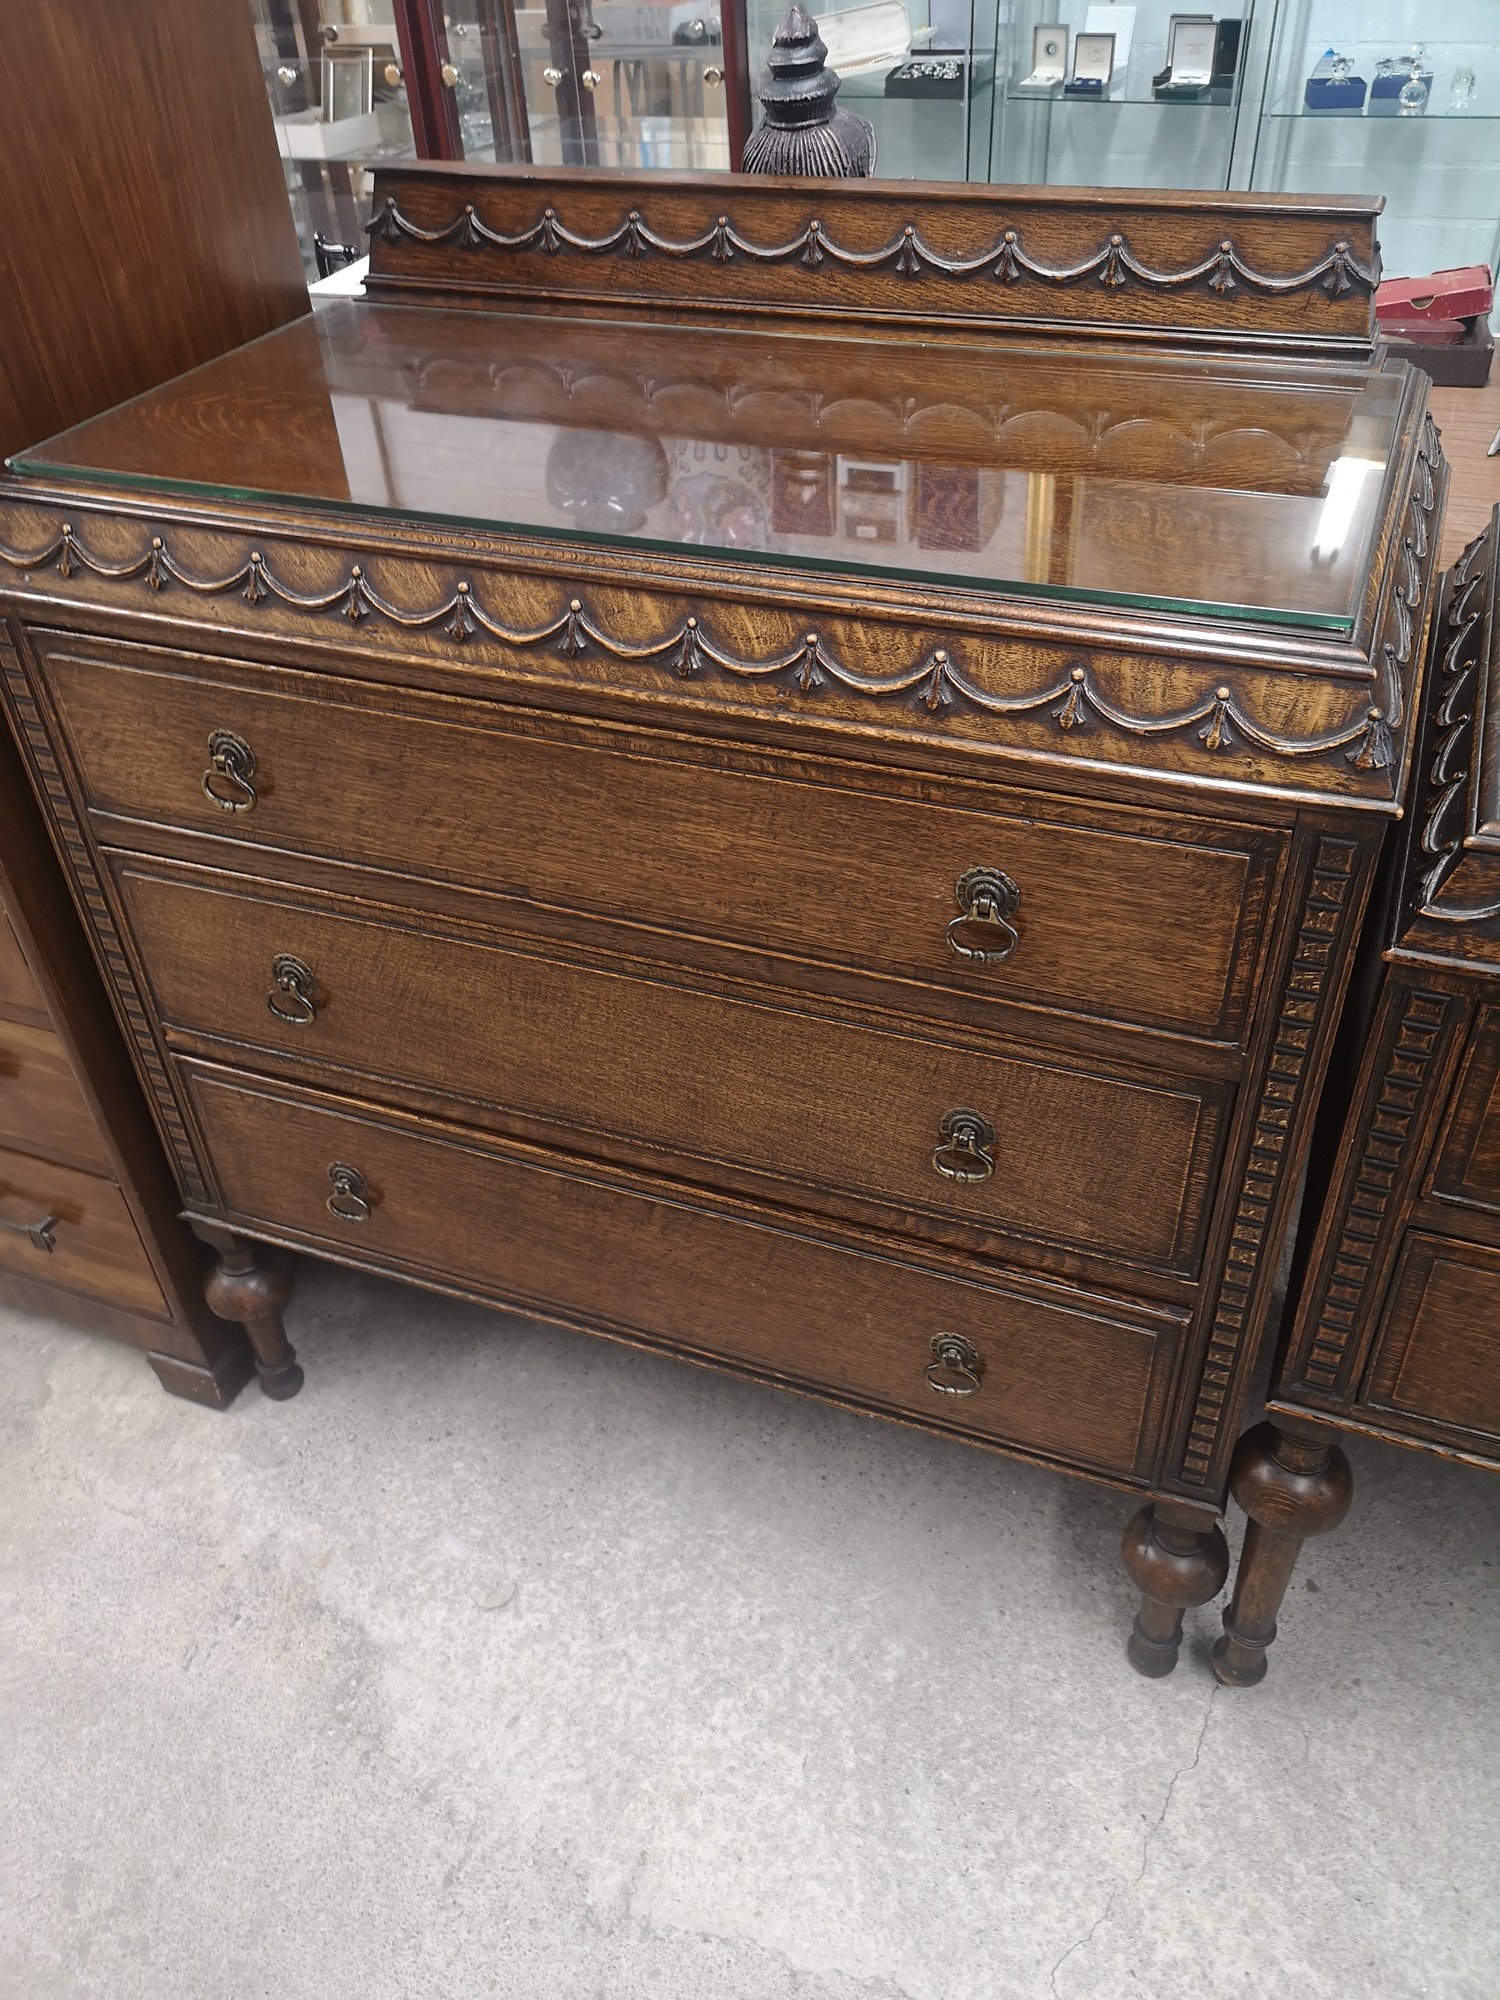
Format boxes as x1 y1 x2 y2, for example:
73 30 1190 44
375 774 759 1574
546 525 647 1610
1214 1420 1354 1688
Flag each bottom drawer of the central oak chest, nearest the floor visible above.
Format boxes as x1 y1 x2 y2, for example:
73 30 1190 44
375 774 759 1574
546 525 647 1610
182 1062 1178 1474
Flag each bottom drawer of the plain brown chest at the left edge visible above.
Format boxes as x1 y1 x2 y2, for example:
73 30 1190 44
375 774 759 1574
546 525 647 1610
0 1148 166 1318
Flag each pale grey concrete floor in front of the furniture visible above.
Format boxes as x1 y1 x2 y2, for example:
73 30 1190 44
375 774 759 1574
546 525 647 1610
0 1266 1500 2000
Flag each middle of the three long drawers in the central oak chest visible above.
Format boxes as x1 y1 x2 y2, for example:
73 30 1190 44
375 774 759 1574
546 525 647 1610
112 854 1230 1276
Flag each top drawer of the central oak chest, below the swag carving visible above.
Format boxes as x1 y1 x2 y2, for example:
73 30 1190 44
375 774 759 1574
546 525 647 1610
38 632 1282 1042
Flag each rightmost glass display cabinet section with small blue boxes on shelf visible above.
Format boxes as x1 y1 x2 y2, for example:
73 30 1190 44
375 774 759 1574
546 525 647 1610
1250 0 1500 278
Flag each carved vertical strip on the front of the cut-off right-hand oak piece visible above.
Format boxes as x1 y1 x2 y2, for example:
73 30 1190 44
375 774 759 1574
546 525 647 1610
1280 986 1464 1398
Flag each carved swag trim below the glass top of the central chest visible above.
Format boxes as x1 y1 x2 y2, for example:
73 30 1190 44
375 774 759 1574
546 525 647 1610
0 516 1408 792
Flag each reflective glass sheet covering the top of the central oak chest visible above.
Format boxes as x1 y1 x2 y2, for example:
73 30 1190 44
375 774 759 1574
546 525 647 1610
12 302 1400 630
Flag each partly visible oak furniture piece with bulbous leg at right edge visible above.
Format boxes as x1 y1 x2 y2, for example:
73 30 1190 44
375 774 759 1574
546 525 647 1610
1214 514 1500 1686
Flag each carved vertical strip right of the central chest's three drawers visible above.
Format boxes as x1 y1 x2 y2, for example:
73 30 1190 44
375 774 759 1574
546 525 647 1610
1176 836 1362 1486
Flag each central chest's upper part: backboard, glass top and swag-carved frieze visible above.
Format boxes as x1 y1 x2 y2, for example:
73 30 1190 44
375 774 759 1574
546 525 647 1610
0 168 1442 810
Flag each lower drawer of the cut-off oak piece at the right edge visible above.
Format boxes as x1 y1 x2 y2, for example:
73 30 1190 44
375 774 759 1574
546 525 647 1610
1362 1232 1500 1460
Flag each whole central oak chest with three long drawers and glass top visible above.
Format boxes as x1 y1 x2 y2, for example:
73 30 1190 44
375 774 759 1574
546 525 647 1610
0 170 1444 1672
